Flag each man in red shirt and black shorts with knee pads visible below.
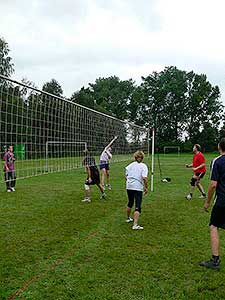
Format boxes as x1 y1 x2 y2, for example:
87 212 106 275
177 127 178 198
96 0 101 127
185 144 206 200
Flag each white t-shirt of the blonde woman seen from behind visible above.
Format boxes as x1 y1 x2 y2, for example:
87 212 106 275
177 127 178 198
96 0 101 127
126 161 148 191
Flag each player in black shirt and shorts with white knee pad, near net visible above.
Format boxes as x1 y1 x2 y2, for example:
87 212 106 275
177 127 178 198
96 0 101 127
82 151 106 202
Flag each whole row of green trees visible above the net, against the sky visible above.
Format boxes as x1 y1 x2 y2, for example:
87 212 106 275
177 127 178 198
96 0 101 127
0 39 225 151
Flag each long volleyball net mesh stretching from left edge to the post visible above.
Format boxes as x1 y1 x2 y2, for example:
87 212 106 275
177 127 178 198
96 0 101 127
0 75 148 181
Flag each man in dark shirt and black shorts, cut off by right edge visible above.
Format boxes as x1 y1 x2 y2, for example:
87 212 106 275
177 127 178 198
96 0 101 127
200 138 225 270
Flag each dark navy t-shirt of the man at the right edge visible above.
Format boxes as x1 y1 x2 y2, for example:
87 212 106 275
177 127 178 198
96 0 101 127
211 155 225 207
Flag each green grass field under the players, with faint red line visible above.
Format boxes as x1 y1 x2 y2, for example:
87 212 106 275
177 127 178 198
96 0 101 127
0 155 225 300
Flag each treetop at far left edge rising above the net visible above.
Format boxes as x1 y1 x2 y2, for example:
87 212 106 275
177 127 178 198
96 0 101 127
0 38 14 77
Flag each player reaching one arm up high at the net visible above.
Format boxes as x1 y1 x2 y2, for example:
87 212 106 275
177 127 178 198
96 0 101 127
100 136 117 190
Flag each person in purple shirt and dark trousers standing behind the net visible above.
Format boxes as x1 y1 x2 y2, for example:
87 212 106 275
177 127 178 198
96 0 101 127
4 145 16 193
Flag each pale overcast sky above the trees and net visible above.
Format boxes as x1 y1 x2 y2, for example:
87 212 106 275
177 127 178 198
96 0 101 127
0 0 225 104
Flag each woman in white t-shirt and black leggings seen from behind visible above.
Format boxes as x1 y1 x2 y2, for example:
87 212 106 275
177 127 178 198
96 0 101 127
126 151 148 229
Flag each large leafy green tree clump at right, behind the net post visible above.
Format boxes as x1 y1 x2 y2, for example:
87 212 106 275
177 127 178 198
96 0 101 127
136 67 223 149
